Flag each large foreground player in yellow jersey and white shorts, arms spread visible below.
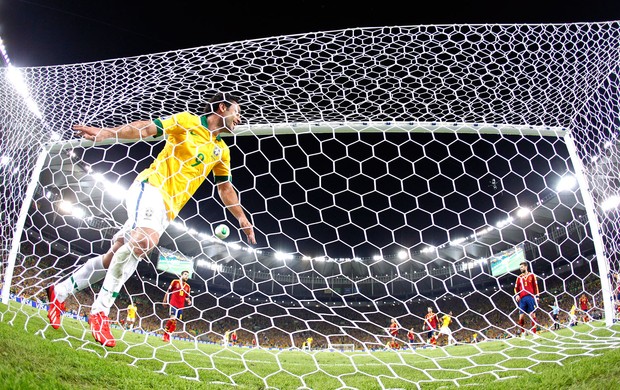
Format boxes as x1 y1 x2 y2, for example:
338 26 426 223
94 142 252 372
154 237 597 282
48 93 256 347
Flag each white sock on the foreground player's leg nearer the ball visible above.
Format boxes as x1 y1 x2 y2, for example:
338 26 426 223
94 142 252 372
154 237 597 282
91 244 140 316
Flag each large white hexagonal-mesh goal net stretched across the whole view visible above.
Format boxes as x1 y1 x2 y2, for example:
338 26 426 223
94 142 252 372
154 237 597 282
0 21 620 388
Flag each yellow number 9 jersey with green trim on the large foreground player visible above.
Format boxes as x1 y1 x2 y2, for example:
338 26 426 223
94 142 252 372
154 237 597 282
136 112 231 221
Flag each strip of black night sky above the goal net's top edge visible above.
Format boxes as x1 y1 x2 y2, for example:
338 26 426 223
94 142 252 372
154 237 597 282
0 0 620 67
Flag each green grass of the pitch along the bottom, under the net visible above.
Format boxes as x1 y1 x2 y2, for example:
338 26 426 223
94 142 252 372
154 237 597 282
0 302 620 389
